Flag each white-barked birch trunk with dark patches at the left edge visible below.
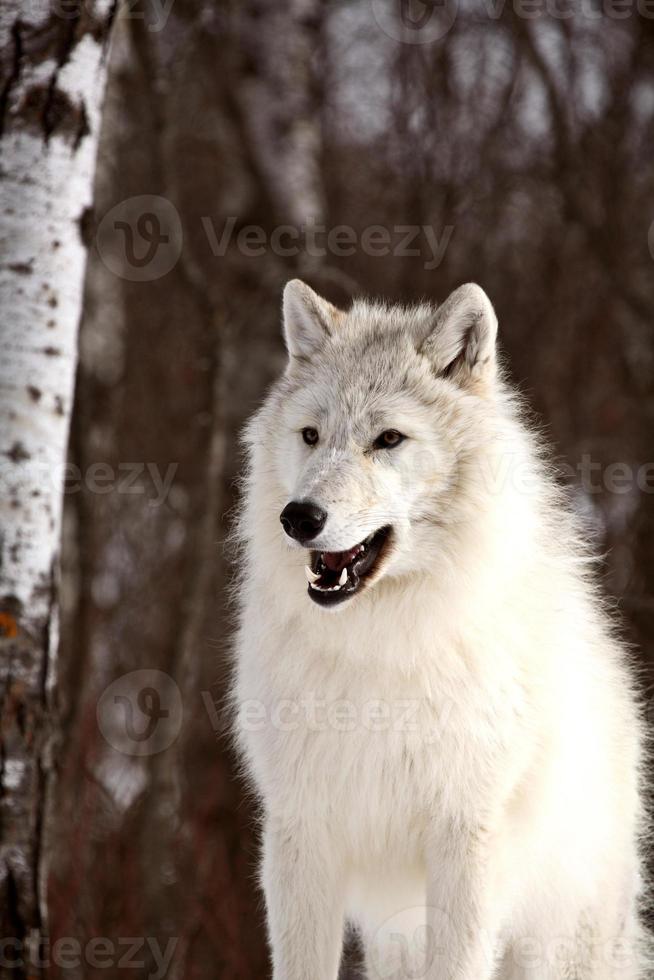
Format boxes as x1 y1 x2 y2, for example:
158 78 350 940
0 0 114 978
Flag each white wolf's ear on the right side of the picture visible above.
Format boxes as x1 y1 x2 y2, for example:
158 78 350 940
420 282 497 385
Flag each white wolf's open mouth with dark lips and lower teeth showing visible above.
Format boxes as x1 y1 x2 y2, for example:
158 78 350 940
305 527 391 606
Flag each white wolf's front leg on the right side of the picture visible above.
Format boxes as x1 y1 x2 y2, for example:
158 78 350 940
425 826 501 980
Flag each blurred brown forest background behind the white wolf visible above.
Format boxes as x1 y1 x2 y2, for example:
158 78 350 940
16 0 654 980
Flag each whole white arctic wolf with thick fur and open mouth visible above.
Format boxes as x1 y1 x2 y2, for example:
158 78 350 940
233 280 649 980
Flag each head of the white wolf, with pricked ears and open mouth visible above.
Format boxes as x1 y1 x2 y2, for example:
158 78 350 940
246 280 512 607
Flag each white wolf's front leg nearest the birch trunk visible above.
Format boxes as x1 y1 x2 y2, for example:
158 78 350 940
262 822 344 980
